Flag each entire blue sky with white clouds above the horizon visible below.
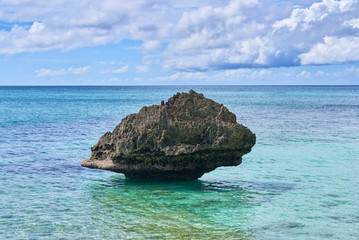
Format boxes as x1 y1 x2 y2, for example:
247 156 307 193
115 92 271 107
0 0 359 85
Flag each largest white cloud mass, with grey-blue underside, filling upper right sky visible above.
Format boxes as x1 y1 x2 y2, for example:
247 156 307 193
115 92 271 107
164 0 359 71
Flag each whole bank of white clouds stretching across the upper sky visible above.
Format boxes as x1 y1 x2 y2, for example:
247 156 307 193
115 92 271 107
0 0 359 72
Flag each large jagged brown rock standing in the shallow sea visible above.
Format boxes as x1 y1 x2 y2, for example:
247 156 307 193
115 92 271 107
81 90 256 180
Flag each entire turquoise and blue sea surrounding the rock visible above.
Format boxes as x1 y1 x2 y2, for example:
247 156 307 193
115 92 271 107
0 86 359 239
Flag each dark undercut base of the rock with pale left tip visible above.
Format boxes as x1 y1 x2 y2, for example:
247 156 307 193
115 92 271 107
81 150 243 180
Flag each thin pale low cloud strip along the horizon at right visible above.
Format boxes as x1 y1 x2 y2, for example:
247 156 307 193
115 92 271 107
145 66 359 85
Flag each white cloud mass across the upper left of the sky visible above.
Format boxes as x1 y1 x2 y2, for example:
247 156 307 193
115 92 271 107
0 0 170 54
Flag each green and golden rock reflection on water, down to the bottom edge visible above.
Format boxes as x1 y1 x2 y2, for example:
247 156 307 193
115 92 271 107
86 176 294 239
